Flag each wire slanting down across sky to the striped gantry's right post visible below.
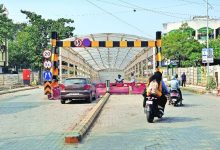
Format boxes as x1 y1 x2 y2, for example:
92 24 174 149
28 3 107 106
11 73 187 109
86 0 153 38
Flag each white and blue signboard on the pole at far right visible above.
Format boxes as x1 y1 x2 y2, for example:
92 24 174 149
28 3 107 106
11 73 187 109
202 48 214 63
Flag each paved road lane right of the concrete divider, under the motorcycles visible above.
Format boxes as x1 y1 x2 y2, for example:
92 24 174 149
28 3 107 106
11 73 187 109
69 92 220 150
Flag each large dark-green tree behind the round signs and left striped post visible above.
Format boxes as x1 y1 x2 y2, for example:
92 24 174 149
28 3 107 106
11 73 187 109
17 10 75 81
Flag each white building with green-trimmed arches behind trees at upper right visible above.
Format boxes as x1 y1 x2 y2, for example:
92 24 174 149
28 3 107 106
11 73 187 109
163 16 220 42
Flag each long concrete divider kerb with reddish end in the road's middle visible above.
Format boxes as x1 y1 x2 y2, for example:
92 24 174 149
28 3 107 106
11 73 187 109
65 93 110 144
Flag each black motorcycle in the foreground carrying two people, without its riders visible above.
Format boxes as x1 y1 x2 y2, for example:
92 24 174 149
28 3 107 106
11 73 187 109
145 97 163 123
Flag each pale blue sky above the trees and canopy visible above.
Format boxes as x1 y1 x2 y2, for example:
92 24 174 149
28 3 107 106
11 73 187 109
0 0 220 39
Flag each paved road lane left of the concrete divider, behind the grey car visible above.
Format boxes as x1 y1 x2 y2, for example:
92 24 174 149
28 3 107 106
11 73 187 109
0 89 95 150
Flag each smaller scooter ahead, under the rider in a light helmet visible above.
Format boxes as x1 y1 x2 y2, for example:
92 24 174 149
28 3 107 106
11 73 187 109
169 90 183 106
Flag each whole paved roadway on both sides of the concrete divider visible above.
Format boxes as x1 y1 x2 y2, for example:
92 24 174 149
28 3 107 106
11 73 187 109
0 89 220 150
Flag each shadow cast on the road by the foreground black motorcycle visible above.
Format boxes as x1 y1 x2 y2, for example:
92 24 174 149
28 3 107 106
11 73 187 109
155 117 201 123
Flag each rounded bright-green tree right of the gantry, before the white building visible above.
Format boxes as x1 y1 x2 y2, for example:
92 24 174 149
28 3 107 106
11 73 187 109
162 24 202 67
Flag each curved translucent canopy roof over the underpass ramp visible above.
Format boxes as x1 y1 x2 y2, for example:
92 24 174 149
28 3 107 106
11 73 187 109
62 33 152 71
